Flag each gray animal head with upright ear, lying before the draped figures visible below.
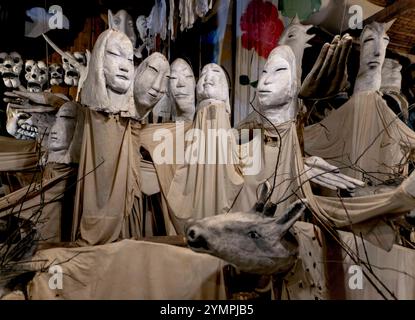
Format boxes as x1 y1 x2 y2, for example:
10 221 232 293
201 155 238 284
185 201 305 275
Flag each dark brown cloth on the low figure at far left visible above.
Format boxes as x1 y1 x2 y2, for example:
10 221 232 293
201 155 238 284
0 163 76 242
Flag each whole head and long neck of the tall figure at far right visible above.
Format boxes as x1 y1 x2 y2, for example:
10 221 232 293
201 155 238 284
353 22 389 93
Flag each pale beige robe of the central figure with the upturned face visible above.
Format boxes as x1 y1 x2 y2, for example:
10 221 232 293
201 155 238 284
167 101 244 219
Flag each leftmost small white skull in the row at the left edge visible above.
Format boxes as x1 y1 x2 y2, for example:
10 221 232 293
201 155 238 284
0 52 23 88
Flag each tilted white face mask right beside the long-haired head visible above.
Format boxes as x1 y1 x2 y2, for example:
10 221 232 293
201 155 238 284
134 53 170 109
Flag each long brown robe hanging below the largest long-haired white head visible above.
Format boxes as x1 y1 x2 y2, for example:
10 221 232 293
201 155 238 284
72 108 140 245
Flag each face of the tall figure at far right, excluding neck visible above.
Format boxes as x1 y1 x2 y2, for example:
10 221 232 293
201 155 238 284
359 28 389 73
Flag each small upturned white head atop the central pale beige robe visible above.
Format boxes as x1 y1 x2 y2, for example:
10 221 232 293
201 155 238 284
196 63 229 102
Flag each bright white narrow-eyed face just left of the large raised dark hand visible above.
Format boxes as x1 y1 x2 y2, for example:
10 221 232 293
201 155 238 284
257 55 294 107
